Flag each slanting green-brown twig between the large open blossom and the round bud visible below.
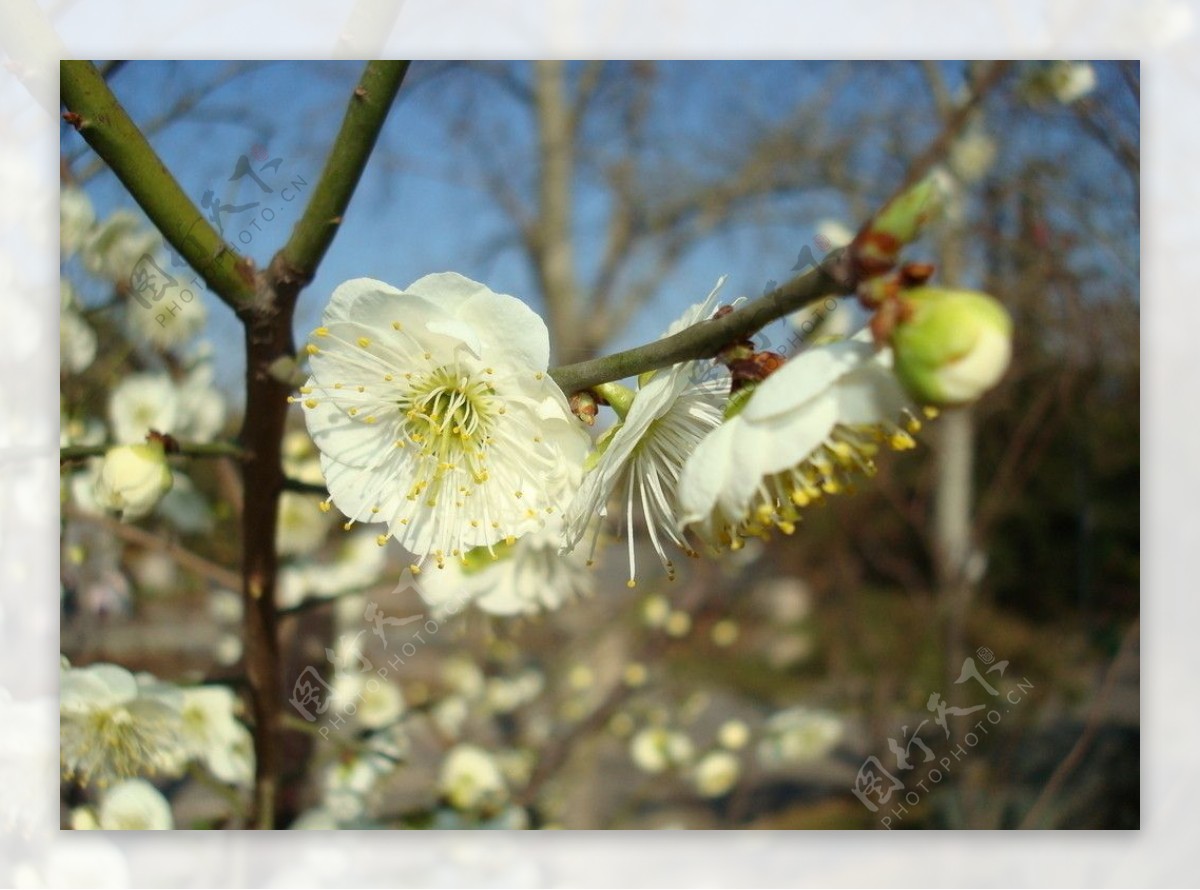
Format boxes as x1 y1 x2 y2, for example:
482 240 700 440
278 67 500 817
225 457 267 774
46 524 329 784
550 251 856 395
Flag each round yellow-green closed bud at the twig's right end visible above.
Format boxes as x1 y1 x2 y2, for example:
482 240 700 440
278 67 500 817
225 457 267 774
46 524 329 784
892 288 1013 405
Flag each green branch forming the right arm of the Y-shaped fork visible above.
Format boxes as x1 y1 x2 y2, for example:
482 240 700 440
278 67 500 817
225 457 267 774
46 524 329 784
276 61 409 283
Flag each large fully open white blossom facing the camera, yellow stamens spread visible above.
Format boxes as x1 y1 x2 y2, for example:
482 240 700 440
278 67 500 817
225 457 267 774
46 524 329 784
299 272 587 565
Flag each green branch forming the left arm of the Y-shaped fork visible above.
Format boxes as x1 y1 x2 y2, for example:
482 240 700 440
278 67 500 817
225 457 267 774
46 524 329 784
59 60 254 308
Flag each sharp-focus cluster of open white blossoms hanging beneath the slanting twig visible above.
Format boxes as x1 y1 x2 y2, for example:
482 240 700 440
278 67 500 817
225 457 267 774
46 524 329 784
295 273 945 615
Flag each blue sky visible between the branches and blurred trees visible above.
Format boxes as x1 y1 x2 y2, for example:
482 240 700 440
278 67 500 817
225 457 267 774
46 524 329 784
64 61 1137 399
